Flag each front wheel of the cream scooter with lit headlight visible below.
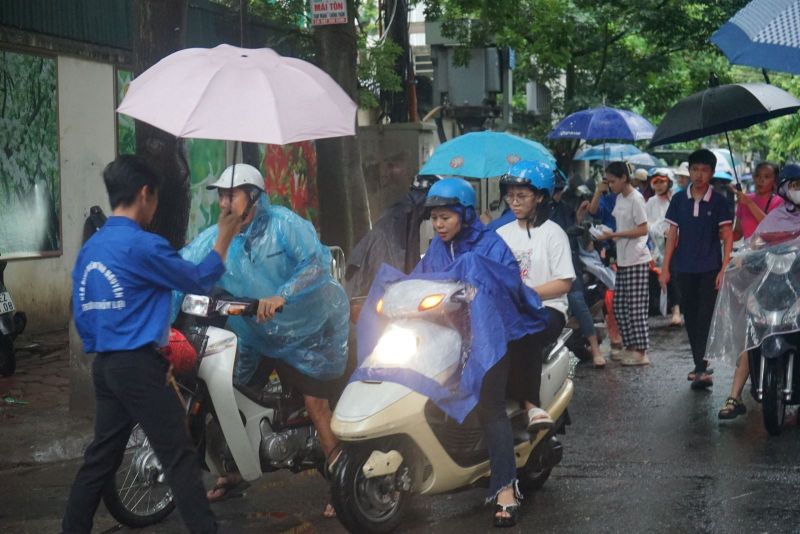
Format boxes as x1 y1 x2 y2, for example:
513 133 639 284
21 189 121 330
331 447 410 534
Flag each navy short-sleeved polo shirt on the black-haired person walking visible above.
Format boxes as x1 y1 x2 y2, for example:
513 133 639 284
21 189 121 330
666 185 733 273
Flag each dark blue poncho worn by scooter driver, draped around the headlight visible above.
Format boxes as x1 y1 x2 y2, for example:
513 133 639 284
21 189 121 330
350 214 547 422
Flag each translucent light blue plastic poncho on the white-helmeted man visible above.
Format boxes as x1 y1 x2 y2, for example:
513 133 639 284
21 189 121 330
181 195 350 383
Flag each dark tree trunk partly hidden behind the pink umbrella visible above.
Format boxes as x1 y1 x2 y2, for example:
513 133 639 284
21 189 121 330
133 0 191 248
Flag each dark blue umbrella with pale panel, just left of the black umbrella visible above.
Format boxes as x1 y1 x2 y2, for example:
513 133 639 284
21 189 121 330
547 106 656 141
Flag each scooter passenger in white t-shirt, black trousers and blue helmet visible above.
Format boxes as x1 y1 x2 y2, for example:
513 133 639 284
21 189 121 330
497 161 575 429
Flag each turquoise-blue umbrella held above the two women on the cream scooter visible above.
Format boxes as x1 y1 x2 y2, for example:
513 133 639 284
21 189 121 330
419 132 556 178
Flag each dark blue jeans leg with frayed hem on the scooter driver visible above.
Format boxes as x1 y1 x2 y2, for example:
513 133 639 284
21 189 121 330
478 356 520 502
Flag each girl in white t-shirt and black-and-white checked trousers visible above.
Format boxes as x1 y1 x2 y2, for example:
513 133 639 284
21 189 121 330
598 161 652 365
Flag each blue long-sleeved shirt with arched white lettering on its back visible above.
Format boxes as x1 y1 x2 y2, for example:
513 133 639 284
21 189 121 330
72 217 225 353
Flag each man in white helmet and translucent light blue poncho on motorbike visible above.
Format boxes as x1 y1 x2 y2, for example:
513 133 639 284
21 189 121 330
181 164 349 517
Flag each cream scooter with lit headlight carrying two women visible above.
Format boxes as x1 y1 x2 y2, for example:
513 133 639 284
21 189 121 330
331 279 573 533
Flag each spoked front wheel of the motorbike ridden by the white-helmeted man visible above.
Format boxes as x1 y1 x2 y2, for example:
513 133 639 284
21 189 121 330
103 425 175 528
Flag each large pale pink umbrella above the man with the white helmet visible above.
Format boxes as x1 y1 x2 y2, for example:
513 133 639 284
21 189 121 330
117 45 356 145
